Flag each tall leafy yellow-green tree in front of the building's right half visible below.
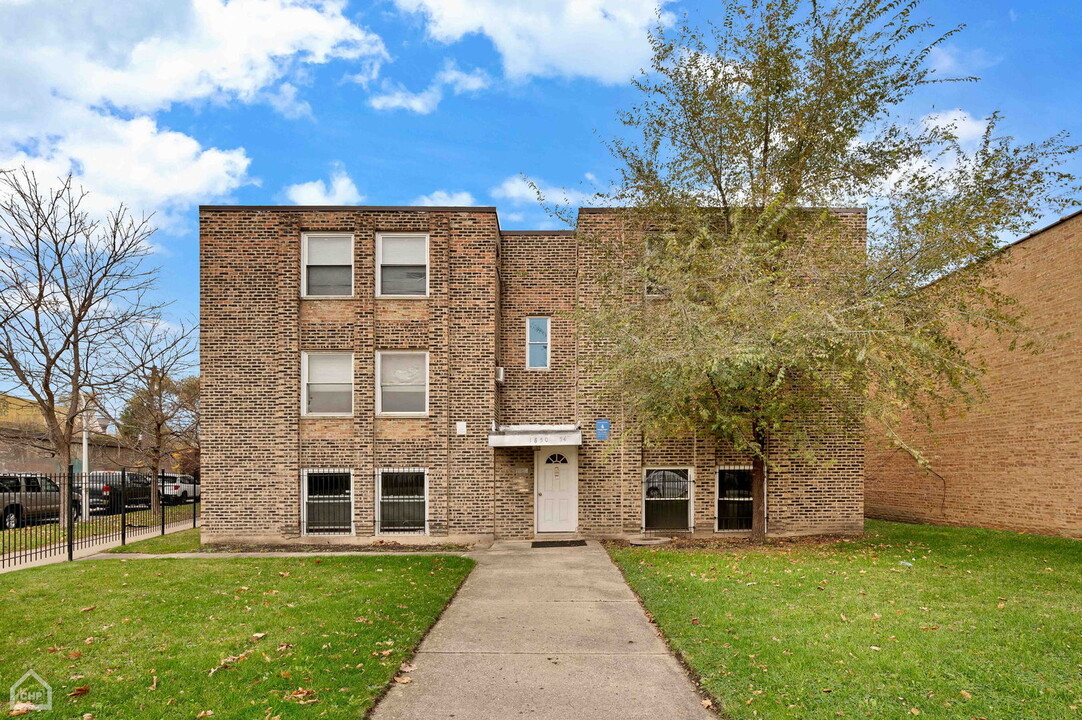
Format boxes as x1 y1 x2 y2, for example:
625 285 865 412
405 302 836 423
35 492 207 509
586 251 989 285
582 0 1079 540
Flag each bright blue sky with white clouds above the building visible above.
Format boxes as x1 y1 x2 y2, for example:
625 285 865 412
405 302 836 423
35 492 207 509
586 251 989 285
0 0 1082 314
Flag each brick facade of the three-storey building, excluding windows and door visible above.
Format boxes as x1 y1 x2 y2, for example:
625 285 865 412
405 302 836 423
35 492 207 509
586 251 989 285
200 208 862 541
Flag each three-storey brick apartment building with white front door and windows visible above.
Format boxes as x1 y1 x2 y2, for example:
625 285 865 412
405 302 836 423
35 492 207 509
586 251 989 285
200 207 865 542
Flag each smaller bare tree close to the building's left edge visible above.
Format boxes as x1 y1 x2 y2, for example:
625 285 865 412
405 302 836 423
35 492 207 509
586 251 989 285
119 325 198 512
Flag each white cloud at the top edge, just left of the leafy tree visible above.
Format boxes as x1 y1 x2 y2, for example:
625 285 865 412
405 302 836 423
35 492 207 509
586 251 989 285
394 0 671 84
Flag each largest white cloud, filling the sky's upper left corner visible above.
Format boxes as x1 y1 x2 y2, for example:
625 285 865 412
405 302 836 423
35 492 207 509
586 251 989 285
0 0 386 225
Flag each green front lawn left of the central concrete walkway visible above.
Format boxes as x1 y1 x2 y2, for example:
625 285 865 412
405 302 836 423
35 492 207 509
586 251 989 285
0 555 473 720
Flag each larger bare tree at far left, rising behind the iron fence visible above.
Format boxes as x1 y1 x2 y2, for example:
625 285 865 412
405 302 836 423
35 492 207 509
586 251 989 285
0 168 173 523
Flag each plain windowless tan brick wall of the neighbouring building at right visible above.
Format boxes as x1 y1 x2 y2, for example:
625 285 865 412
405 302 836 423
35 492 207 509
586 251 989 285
866 215 1082 537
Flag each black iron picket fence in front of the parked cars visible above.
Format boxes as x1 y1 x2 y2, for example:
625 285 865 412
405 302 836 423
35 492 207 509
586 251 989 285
0 470 200 567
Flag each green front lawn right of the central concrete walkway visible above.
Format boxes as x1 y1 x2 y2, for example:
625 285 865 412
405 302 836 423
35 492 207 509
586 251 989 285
610 522 1082 720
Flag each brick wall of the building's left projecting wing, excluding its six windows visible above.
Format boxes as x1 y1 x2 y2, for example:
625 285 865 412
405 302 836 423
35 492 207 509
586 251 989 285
200 208 498 540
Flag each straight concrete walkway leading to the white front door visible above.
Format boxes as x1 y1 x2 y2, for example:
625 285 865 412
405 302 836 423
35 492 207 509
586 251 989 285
371 542 714 720
